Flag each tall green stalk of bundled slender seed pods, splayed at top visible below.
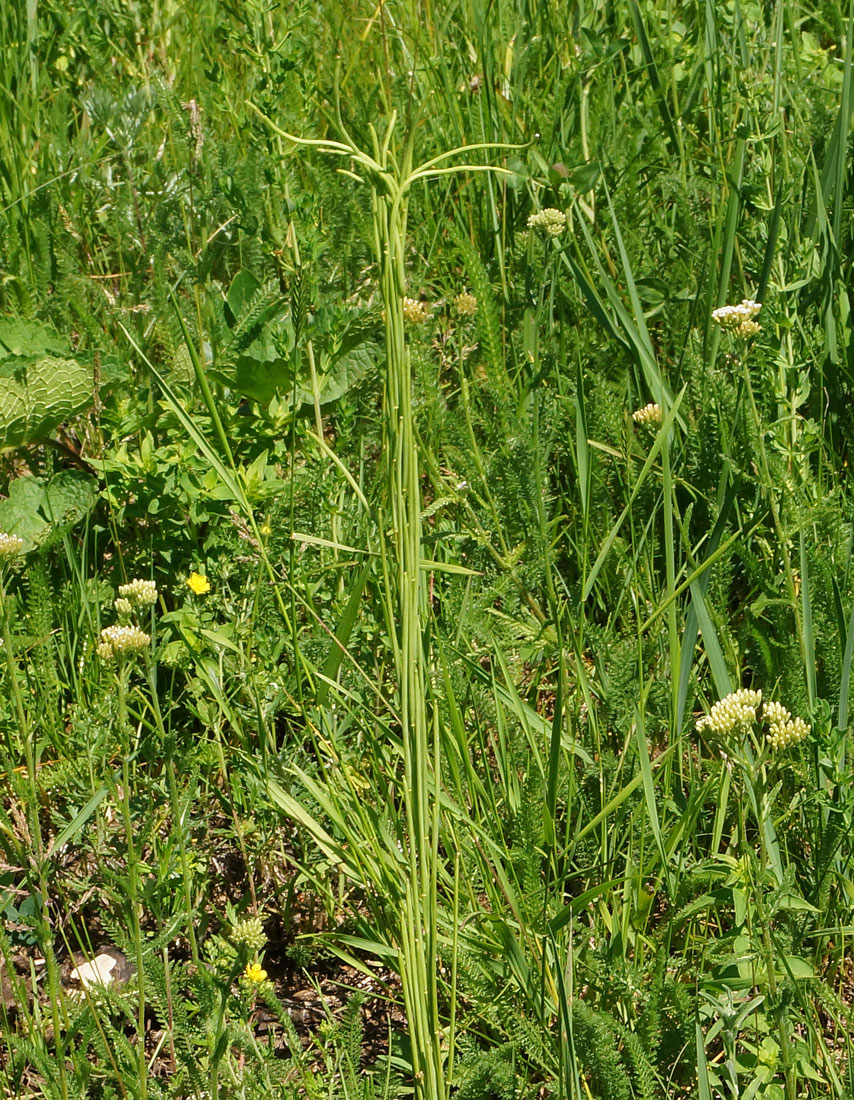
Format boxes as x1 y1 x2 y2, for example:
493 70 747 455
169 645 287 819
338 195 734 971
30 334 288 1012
249 96 517 1100
